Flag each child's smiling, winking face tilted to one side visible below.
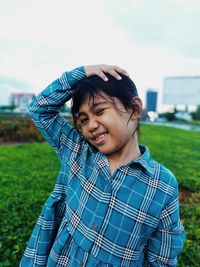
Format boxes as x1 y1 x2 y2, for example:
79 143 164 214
77 92 141 159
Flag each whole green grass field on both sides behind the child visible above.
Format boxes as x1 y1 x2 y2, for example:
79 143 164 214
0 125 200 267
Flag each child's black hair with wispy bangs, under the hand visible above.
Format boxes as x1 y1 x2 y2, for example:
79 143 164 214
71 74 139 131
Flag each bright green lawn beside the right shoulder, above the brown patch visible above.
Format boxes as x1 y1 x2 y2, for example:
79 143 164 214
140 125 200 192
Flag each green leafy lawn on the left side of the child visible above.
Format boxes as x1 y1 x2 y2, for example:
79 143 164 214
0 143 59 267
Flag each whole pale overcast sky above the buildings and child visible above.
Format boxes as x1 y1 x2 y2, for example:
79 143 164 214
0 0 200 111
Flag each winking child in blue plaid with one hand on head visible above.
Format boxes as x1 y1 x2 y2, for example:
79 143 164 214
20 65 185 267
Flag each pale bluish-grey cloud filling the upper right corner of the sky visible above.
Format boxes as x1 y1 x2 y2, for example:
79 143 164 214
104 0 200 58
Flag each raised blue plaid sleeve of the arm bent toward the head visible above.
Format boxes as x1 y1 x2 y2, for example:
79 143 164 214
29 67 85 157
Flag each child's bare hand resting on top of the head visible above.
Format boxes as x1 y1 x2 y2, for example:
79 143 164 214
84 64 128 81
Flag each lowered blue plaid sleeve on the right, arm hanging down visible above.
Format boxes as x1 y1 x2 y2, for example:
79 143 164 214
147 185 185 267
